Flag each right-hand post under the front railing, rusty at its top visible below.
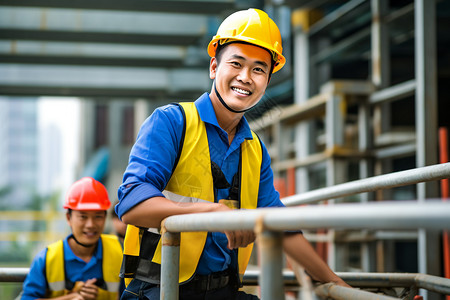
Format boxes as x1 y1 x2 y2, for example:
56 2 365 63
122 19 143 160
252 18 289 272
258 230 284 300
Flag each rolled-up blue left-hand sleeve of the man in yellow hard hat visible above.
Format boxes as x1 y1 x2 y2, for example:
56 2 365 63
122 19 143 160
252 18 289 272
115 104 184 218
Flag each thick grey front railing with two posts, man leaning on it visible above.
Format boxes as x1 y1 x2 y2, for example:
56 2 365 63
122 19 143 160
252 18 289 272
161 202 450 300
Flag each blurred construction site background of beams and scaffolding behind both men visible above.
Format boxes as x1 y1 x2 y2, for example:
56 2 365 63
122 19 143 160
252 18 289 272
0 0 450 300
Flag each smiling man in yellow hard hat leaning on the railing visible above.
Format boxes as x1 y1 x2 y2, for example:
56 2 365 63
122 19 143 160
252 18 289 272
116 9 346 300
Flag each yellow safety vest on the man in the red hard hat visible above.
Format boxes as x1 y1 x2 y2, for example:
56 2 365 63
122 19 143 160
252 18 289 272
45 234 122 300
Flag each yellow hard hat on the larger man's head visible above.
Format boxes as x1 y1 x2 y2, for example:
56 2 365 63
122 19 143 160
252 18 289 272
208 8 286 73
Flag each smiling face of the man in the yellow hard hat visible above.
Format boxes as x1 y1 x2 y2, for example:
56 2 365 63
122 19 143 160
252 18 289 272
209 43 272 111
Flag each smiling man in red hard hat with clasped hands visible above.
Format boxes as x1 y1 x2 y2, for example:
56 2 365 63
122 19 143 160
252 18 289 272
21 177 122 300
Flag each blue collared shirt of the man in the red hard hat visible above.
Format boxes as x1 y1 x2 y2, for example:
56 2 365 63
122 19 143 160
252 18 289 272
21 234 103 300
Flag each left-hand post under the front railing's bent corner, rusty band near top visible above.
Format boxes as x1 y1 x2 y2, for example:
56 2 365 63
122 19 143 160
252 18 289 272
160 230 181 300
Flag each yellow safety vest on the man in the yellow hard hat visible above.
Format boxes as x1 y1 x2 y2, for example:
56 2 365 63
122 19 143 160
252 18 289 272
122 102 262 285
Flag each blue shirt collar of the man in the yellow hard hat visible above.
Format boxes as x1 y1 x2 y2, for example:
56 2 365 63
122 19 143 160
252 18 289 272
195 93 253 140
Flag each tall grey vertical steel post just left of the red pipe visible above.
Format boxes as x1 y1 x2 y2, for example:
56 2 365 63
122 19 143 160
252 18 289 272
414 0 441 300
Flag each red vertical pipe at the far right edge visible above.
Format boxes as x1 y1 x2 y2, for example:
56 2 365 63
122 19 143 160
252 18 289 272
439 127 450 300
